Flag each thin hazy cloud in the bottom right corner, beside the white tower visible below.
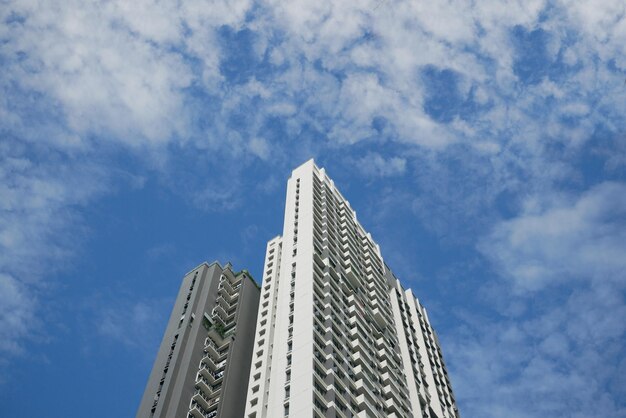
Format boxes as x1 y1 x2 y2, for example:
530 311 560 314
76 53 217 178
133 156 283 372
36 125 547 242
442 285 626 418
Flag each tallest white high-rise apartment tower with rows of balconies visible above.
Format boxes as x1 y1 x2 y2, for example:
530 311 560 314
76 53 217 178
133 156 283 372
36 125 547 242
245 160 459 418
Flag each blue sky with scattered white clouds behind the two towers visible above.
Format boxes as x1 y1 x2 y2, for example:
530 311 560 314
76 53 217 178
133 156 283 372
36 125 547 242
0 0 626 418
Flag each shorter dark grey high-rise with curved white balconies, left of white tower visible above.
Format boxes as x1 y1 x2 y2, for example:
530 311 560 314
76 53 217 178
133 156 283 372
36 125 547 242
137 262 259 418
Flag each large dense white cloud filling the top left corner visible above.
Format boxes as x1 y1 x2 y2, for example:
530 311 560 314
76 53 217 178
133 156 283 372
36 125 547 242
2 0 250 146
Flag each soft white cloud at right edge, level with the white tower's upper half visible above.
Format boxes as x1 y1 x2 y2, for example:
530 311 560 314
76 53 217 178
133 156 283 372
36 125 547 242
480 183 626 290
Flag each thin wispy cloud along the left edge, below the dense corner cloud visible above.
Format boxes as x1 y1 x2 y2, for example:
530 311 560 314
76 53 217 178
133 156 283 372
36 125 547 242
0 146 108 361
